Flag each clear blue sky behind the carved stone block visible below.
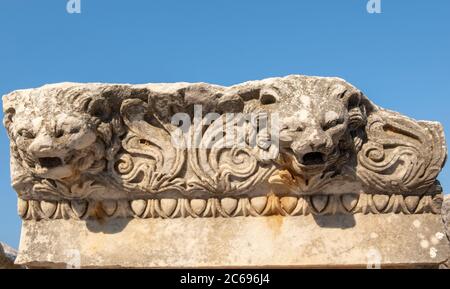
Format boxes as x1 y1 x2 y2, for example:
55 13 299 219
0 0 450 247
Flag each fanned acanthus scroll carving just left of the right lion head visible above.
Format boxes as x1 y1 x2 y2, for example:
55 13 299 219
187 111 275 195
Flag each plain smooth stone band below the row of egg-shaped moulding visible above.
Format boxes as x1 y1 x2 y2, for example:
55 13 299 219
16 214 450 268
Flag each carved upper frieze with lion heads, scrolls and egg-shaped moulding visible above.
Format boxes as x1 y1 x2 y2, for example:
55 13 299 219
3 75 447 213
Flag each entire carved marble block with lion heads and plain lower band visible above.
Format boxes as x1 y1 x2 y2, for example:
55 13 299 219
3 75 449 267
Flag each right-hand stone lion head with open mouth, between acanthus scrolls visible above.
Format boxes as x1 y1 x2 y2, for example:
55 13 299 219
225 76 366 189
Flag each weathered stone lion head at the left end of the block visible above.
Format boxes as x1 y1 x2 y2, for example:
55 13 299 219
4 85 124 196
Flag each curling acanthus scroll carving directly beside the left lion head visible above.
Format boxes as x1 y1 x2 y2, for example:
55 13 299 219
109 99 186 193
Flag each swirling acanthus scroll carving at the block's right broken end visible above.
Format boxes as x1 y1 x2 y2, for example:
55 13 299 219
357 111 447 194
